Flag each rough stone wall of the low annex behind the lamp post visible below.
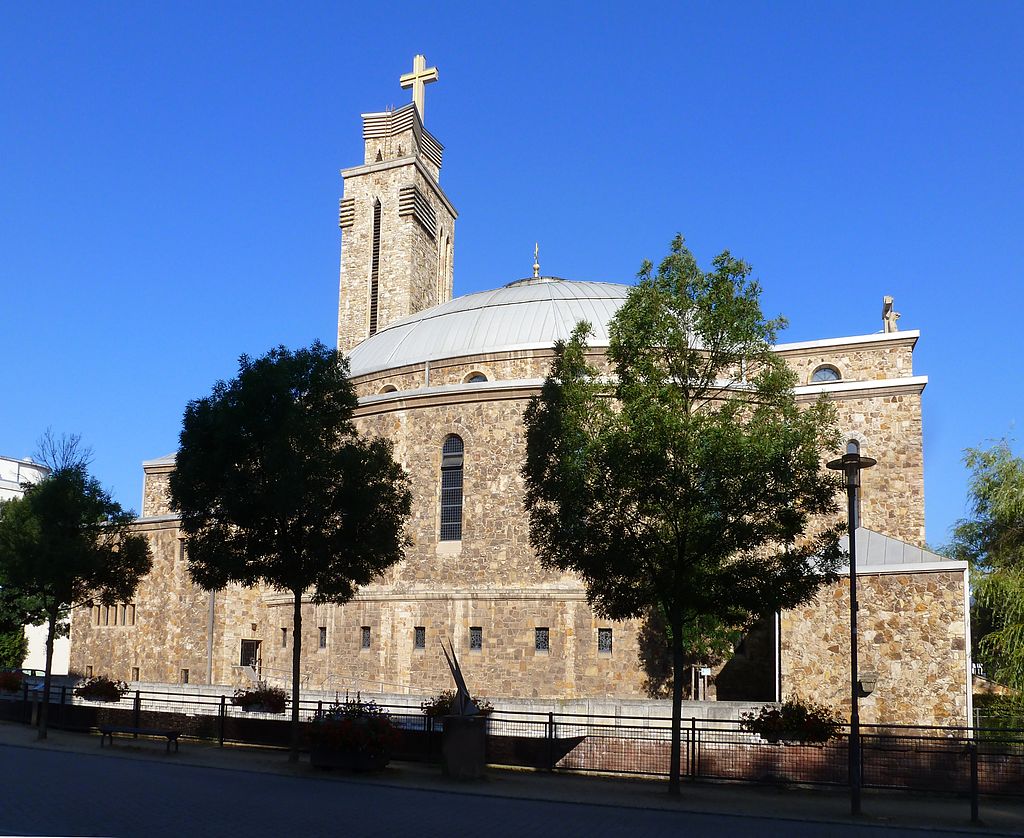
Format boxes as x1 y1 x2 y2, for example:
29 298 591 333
781 571 968 725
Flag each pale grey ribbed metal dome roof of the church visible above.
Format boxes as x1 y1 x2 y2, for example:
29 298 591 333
349 277 630 375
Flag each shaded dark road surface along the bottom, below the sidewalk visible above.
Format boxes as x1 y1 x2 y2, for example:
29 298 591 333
0 746 1007 838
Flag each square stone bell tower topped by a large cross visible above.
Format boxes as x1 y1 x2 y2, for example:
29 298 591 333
338 55 458 353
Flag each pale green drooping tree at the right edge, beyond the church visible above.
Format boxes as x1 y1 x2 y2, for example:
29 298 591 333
945 439 1024 690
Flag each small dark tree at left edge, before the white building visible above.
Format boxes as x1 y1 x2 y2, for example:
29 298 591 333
0 460 152 739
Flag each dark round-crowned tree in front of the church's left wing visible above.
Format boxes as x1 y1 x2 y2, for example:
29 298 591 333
170 342 412 761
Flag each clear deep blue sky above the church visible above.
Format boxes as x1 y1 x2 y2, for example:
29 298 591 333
0 2 1024 544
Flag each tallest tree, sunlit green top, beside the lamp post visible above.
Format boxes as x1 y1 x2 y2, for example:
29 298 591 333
523 237 842 794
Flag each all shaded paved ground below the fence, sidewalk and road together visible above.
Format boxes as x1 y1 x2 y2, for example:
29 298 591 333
0 723 1024 838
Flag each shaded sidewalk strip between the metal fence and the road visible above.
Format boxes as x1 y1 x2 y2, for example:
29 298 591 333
0 722 1024 835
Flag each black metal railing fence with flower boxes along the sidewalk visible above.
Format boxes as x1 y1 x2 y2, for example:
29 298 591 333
0 686 1024 798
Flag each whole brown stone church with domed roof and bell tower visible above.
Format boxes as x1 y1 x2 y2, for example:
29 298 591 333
72 59 970 724
